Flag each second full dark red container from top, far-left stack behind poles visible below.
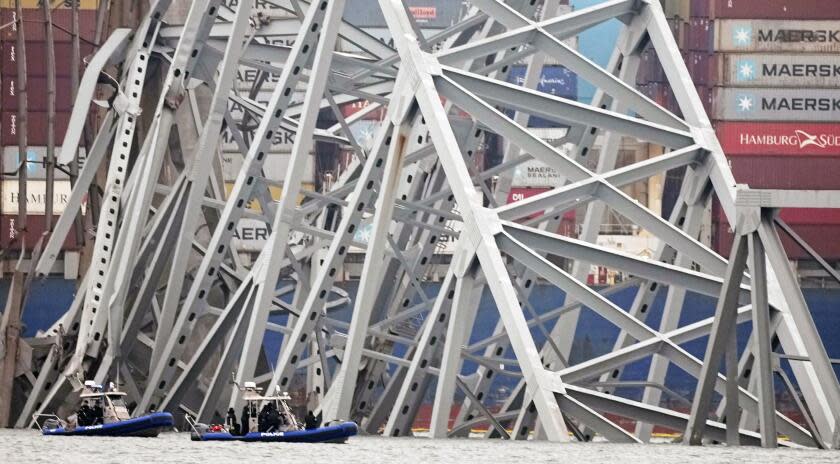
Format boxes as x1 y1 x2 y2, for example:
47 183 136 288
0 40 94 78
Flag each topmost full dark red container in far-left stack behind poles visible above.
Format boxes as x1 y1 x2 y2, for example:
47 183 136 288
0 8 96 43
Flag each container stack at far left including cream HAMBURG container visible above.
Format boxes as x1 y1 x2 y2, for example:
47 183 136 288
0 0 99 250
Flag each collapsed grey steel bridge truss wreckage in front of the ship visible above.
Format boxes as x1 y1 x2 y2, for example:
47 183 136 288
6 0 840 447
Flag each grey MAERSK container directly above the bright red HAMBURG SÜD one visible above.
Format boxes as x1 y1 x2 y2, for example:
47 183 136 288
714 87 840 122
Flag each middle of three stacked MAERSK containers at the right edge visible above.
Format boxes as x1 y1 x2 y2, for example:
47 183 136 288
718 53 840 88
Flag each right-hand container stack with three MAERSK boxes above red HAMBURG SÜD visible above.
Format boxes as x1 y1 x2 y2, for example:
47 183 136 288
691 0 840 260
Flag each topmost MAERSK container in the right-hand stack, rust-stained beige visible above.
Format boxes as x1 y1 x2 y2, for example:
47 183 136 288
715 19 840 53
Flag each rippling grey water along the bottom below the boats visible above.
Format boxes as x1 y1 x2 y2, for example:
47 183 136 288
0 430 840 464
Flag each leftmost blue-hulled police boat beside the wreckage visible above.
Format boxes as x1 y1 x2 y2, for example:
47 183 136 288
32 380 175 437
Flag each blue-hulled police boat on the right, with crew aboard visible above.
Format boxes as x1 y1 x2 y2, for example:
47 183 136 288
186 382 359 443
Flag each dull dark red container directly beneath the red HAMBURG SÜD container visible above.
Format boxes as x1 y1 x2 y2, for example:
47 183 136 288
728 155 840 190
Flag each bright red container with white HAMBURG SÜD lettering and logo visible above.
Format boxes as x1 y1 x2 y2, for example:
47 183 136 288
716 122 840 156
